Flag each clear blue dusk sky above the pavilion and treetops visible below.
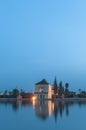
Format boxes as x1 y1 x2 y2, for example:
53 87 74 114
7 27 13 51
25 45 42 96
0 0 86 91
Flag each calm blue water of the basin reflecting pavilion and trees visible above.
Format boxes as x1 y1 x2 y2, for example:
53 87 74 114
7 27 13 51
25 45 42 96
0 100 86 130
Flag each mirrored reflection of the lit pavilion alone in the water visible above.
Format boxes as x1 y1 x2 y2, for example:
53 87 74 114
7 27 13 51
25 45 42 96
35 100 52 120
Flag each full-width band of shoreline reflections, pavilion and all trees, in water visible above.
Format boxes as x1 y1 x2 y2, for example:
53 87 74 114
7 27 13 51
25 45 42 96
0 100 86 122
